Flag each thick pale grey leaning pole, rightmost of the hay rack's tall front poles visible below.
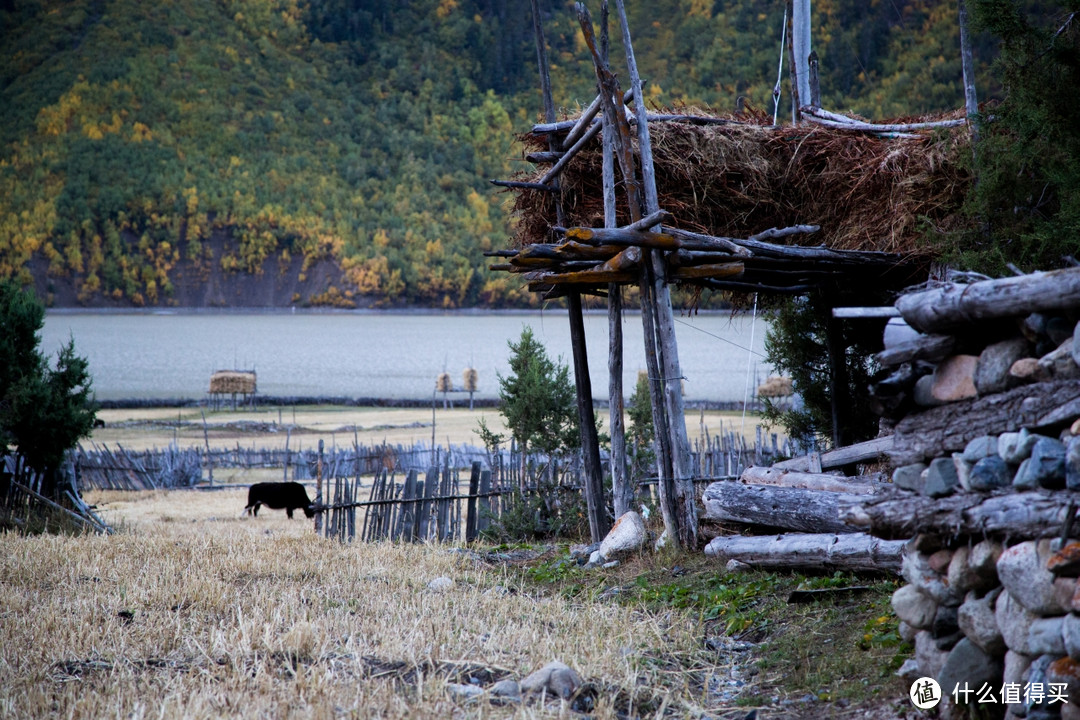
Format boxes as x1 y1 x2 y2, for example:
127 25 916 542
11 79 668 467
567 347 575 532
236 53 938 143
616 0 699 549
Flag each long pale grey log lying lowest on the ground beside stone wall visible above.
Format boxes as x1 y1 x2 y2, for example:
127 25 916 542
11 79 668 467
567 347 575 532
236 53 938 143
705 532 906 572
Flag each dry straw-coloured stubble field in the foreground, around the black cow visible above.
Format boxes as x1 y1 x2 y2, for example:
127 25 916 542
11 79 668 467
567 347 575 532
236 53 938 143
0 490 745 719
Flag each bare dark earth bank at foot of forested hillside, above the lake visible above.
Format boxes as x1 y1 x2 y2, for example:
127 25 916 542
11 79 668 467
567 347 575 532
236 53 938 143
30 230 354 308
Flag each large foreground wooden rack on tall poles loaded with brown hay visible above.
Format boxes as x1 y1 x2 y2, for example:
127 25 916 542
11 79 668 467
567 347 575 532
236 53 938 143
488 0 970 547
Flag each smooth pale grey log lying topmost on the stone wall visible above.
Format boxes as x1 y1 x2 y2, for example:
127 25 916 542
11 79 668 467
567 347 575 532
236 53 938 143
896 268 1080 332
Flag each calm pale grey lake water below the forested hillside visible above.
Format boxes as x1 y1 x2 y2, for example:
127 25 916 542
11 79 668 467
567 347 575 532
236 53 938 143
42 310 769 402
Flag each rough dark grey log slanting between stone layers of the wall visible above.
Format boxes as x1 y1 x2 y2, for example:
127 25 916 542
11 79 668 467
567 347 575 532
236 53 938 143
889 380 1080 465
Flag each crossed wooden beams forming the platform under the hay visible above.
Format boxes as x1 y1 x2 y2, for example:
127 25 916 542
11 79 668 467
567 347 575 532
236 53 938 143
485 210 905 297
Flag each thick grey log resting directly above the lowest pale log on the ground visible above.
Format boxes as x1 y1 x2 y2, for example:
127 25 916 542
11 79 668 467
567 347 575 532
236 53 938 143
702 480 865 532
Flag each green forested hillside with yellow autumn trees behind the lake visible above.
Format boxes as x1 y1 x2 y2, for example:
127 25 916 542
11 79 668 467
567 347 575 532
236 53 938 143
0 0 996 307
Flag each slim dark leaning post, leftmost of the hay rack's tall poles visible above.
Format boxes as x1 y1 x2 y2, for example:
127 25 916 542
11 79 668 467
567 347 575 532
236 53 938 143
531 0 609 543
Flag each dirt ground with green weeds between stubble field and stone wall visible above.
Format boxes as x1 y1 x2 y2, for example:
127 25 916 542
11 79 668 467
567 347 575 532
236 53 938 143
524 554 912 706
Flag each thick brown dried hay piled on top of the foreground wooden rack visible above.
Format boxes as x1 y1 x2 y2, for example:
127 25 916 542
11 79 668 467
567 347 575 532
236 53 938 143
514 105 971 256
